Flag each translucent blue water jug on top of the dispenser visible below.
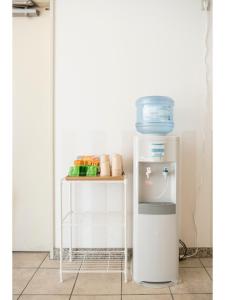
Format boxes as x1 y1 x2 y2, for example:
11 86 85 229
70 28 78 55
136 96 174 135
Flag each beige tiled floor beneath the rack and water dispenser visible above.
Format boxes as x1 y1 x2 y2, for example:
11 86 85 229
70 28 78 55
13 252 212 300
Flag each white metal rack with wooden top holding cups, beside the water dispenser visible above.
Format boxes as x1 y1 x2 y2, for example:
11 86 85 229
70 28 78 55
60 175 128 282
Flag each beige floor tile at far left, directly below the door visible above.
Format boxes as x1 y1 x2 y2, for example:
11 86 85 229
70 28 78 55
13 252 47 268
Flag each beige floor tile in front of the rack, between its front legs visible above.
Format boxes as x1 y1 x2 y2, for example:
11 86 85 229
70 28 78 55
73 273 121 295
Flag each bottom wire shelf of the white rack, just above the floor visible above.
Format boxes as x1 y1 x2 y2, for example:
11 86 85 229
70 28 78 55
62 249 125 273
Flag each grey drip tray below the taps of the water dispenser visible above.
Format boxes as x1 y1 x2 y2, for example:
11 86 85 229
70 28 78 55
138 202 176 215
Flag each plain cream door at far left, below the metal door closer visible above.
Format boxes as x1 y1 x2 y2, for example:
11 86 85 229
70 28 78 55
13 11 52 251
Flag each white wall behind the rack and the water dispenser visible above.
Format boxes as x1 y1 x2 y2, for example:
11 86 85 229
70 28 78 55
55 0 212 247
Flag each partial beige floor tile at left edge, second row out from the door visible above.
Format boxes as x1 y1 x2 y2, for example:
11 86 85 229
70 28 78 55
13 269 36 295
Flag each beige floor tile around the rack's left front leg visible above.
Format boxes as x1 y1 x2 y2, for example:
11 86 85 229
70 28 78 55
23 269 77 295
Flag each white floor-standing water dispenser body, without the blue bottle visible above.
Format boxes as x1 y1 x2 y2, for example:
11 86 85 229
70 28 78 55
133 135 179 284
